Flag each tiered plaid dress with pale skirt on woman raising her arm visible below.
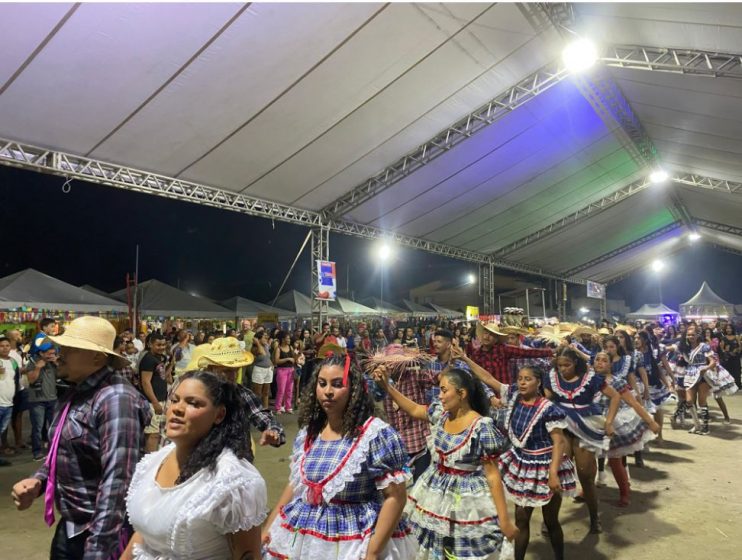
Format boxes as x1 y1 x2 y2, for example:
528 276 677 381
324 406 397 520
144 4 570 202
405 400 505 560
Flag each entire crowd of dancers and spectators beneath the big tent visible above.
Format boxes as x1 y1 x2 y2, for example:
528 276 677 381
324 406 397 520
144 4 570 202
0 317 740 560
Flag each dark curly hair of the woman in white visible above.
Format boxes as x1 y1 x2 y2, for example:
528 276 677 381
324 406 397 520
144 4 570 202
172 370 250 484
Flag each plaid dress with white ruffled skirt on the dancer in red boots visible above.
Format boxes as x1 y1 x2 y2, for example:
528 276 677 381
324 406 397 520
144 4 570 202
598 374 656 458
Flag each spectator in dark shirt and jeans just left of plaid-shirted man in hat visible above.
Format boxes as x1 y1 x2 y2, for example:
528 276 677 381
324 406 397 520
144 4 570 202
23 337 57 461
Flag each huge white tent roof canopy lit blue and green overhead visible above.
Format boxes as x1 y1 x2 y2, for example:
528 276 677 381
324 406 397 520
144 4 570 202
0 3 742 283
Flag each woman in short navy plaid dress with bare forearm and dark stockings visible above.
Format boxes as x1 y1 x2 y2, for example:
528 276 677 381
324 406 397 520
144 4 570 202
499 366 576 560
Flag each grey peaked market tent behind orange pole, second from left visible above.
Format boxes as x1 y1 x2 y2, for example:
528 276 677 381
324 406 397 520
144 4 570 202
111 279 234 319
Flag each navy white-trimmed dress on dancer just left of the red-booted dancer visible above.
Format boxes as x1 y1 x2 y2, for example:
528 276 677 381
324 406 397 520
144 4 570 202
544 369 610 453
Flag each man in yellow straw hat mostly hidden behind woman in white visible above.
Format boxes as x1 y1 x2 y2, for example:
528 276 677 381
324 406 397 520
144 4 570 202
186 337 286 463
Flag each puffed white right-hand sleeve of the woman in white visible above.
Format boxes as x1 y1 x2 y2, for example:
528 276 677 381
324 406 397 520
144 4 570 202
205 454 268 535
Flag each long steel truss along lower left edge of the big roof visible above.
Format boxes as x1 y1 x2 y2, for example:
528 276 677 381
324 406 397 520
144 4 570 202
0 139 585 284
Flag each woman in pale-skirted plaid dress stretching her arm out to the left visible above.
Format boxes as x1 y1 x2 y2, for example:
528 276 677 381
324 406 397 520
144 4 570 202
374 366 517 560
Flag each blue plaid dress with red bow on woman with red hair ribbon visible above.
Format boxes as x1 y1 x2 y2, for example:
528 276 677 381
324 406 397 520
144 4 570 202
263 418 417 560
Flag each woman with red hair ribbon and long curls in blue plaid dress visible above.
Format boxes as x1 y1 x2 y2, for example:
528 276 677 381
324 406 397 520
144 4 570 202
263 351 417 560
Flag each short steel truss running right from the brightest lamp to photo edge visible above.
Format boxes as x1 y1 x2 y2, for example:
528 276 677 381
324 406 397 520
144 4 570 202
600 45 742 79
